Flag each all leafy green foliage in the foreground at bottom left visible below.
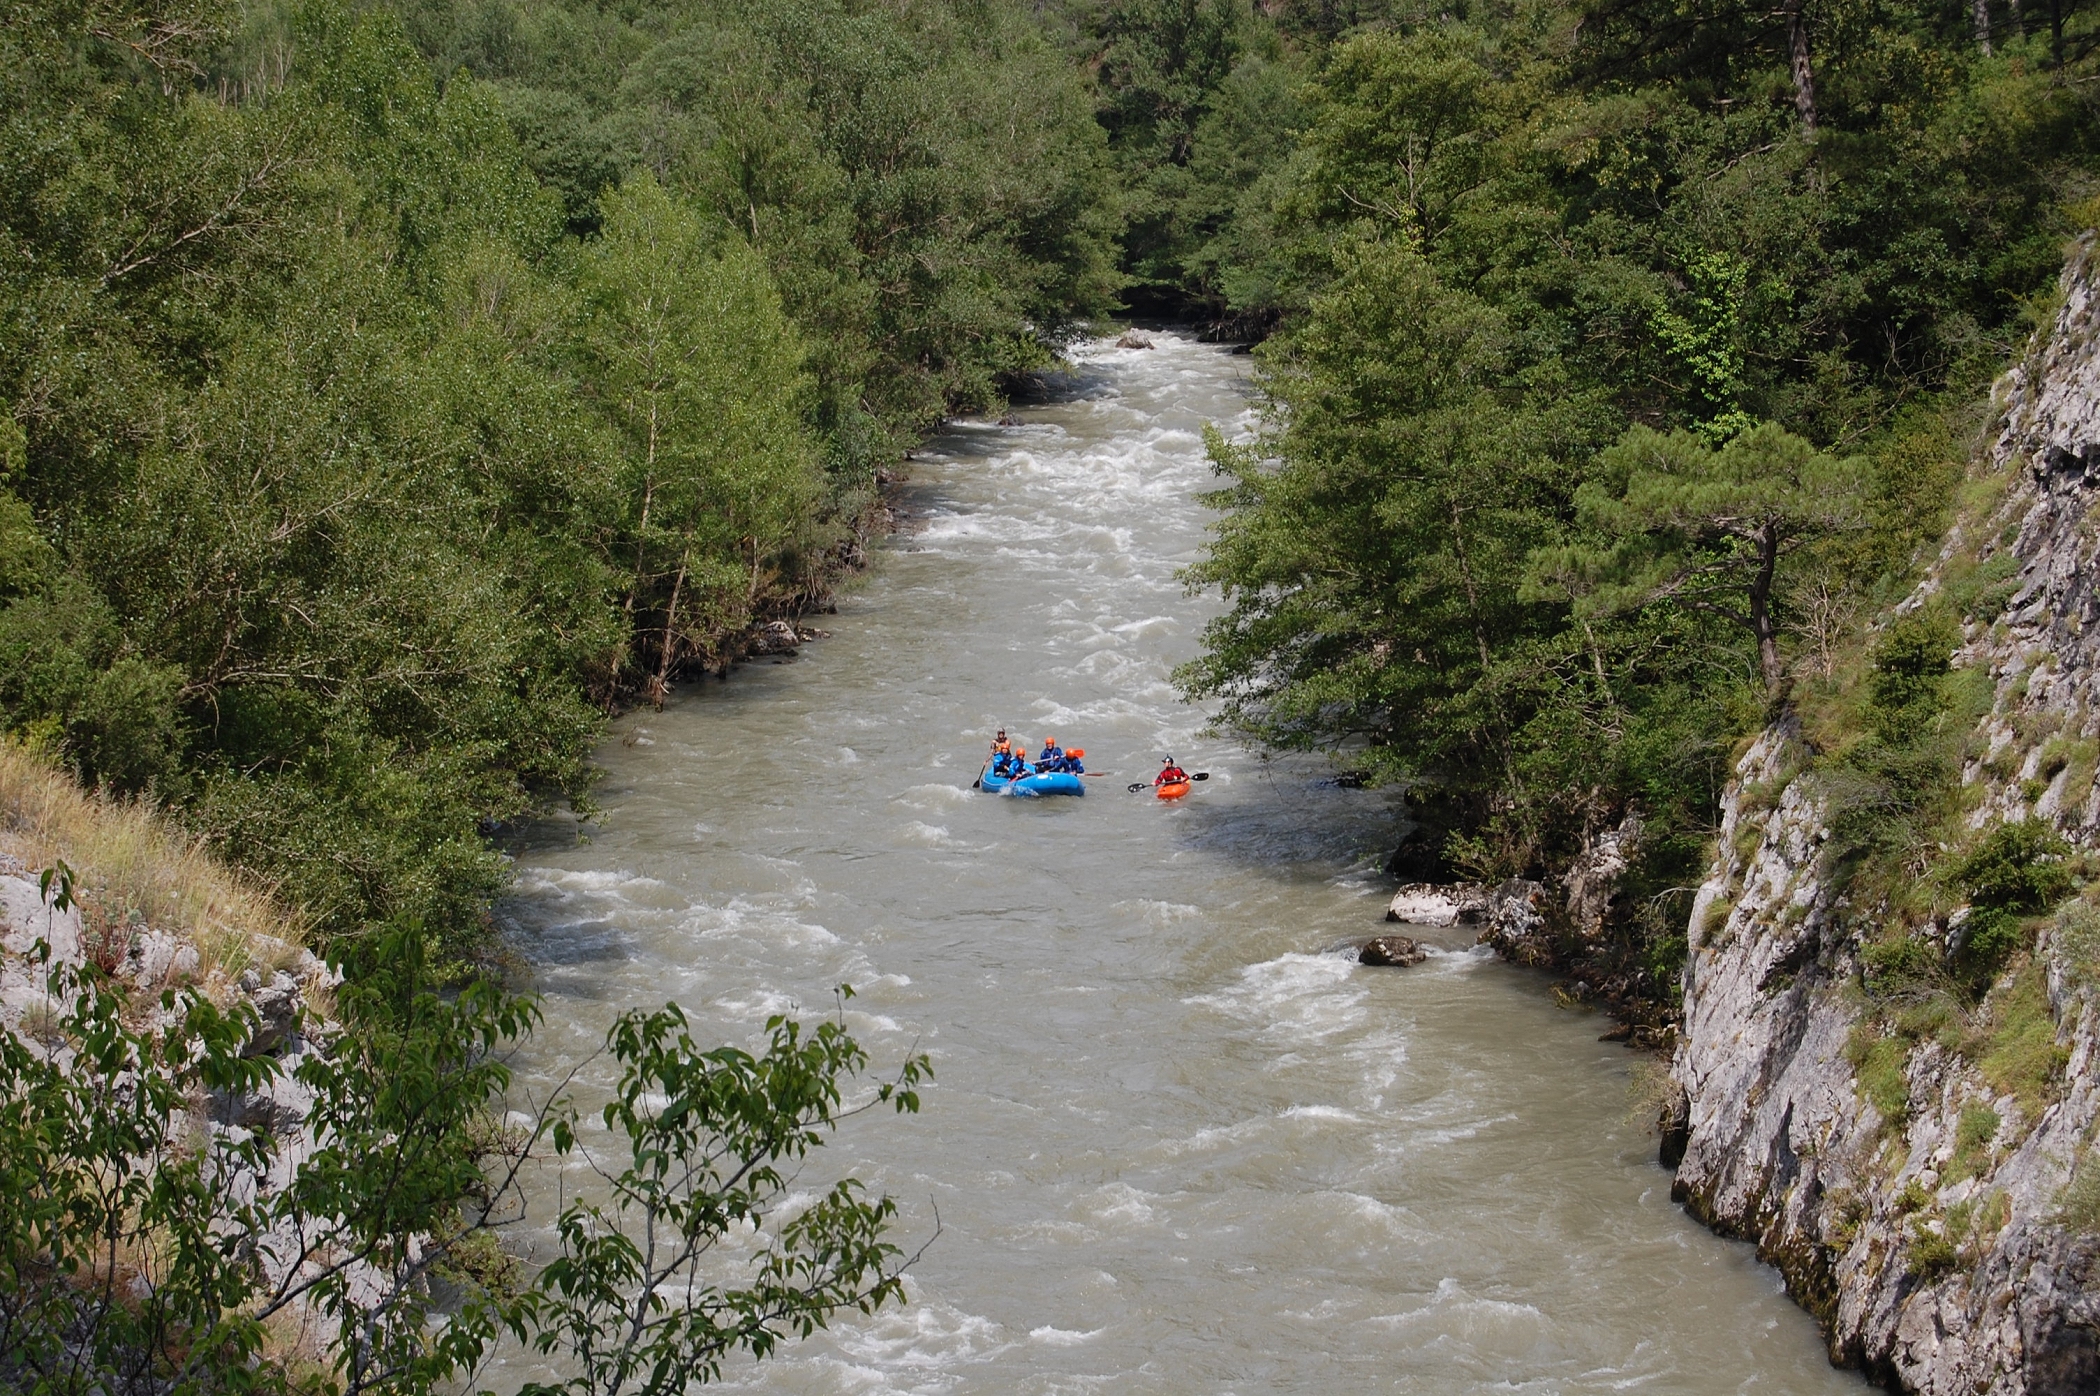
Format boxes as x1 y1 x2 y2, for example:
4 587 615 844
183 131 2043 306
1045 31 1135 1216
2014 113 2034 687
0 923 926 1396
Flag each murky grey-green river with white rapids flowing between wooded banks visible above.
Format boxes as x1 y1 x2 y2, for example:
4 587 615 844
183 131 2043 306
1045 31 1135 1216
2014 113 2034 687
502 336 1865 1396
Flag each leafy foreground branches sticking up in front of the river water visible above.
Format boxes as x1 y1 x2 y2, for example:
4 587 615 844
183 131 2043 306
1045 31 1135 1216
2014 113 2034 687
519 991 928 1396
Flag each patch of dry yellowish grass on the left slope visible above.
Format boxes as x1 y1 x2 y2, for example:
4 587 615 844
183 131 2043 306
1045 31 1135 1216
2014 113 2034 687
0 739 305 978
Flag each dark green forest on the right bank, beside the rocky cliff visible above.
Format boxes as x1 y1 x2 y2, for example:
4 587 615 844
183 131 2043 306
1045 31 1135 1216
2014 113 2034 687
1159 0 2100 1012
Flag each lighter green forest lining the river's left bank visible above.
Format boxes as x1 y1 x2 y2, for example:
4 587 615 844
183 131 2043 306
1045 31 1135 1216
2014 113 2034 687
0 0 1117 965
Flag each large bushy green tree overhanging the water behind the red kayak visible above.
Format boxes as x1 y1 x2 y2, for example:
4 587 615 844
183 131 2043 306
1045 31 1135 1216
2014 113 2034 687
1178 244 1583 789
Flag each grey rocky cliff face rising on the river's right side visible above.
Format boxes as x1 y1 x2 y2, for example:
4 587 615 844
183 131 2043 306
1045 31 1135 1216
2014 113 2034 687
1665 244 2100 1396
